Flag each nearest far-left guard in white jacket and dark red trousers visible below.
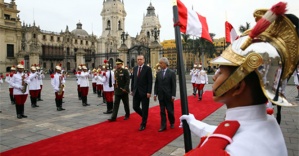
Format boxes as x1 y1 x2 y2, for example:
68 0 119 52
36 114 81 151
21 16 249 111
10 61 30 119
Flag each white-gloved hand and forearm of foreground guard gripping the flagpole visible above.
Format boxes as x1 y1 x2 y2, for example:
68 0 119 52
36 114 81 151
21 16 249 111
180 114 217 137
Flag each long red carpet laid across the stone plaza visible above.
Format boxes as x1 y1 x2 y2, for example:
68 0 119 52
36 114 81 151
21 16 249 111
0 91 222 156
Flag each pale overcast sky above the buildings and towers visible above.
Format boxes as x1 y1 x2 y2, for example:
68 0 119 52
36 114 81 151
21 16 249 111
4 0 299 41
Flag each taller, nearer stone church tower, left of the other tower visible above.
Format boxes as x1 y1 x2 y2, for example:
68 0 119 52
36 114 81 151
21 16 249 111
98 0 127 53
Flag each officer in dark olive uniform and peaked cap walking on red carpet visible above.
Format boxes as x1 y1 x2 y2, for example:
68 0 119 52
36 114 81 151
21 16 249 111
108 59 130 121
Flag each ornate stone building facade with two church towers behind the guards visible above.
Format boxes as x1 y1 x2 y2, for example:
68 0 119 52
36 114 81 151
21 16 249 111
0 0 162 72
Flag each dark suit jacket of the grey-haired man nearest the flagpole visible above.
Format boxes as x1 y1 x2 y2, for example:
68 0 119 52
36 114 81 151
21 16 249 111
154 69 176 100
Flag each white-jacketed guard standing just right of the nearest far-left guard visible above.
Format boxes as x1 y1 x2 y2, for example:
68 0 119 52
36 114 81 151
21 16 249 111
28 65 40 108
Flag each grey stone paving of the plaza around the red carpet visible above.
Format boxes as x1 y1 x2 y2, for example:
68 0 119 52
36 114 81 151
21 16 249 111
0 77 299 156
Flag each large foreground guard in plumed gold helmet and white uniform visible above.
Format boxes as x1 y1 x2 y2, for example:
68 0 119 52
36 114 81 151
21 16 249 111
180 2 299 156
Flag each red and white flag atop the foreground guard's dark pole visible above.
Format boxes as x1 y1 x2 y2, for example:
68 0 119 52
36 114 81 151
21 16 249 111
177 0 212 42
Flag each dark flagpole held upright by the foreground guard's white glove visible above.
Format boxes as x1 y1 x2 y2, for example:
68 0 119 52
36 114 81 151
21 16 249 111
172 0 192 153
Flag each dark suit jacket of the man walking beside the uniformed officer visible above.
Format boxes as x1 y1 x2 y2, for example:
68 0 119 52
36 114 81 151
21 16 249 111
131 65 153 97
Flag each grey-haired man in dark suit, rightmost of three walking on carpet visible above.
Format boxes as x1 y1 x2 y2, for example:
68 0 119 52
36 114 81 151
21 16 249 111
154 57 176 132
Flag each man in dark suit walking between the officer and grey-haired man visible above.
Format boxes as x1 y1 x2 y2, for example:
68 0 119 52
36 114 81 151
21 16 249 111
131 55 153 131
